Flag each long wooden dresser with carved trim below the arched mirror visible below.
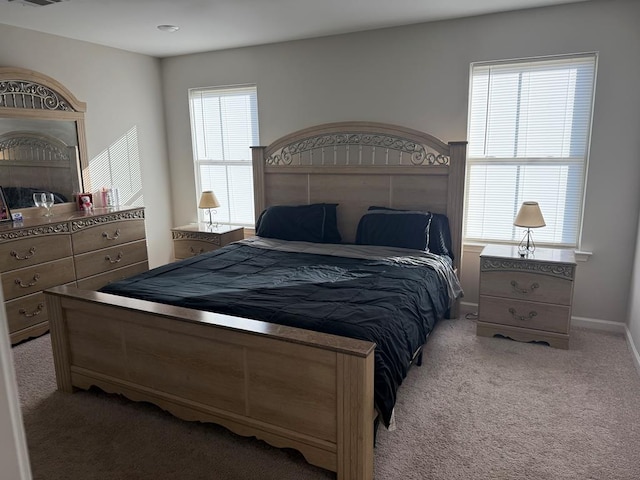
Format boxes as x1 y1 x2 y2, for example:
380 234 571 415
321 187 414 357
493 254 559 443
0 207 149 343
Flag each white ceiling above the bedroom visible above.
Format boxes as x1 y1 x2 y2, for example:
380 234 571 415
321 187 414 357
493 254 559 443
0 0 587 57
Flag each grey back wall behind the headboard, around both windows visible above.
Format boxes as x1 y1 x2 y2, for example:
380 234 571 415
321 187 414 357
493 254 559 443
162 0 640 322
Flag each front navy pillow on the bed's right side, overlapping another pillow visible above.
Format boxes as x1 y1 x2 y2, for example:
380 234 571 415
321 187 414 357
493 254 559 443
356 210 431 250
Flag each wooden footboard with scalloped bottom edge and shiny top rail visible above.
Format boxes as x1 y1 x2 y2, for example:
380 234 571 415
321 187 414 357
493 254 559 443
45 287 375 480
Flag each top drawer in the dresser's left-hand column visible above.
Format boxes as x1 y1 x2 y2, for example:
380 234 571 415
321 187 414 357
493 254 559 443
0 234 71 272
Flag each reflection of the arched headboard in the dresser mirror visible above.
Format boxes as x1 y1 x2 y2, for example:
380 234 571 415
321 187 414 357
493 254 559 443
0 132 70 165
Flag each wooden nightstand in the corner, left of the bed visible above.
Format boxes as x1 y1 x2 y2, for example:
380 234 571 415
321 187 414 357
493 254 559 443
171 223 244 260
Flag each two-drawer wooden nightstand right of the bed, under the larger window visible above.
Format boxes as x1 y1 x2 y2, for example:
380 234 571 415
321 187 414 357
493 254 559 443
476 245 576 348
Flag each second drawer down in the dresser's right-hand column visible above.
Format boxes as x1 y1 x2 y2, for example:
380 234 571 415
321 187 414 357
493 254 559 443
75 240 147 285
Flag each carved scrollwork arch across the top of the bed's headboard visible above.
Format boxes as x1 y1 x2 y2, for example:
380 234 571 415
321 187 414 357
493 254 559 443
265 132 450 165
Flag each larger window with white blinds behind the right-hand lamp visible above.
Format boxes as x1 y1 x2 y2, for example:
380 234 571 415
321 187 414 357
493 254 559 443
465 54 597 247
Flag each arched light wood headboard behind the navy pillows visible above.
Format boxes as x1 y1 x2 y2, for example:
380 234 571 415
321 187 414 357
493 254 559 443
252 122 467 274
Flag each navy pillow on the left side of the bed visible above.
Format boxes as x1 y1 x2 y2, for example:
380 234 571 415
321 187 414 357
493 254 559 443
256 203 342 243
